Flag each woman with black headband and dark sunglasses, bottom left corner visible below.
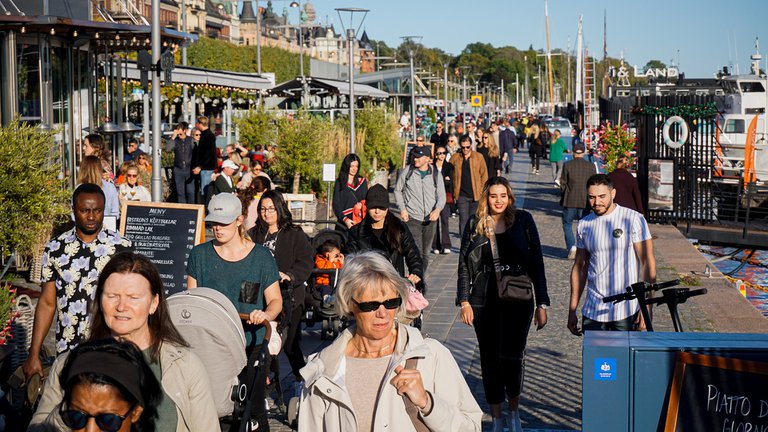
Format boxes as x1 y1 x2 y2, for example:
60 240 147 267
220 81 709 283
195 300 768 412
49 338 163 432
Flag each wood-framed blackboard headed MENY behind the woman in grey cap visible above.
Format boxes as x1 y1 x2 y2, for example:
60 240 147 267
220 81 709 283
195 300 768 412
120 201 205 294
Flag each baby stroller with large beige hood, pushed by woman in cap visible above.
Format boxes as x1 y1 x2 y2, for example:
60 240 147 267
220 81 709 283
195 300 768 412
167 288 271 432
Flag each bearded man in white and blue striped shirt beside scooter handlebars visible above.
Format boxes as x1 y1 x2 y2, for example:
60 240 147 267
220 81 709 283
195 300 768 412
568 174 656 336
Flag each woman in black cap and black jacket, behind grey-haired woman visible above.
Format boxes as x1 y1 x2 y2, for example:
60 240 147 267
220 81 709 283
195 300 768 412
347 185 424 291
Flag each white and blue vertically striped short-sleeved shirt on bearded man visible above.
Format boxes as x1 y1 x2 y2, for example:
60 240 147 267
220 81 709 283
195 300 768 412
576 204 651 322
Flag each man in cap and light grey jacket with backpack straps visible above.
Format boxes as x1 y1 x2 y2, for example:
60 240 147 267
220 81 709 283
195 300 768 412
395 146 445 273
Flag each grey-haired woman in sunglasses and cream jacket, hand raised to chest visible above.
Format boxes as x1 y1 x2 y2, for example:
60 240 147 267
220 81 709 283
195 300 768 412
299 252 482 432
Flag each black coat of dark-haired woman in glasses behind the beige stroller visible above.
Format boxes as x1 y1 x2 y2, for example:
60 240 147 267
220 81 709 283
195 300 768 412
248 225 314 304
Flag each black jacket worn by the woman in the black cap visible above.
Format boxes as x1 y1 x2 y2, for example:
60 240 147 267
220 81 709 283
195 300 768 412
347 218 424 288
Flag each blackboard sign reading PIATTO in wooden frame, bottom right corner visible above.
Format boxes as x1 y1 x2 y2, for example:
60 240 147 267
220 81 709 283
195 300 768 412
664 352 768 432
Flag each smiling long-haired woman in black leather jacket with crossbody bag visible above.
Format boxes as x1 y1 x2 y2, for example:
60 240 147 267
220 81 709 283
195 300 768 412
456 177 549 432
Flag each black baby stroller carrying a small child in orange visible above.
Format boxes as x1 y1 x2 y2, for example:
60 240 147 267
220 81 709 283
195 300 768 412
304 221 347 340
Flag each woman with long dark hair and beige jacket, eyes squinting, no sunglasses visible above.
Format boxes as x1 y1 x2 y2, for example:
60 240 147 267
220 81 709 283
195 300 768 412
32 252 220 432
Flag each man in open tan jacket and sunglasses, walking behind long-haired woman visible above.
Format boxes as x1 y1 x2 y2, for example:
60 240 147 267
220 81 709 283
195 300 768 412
451 135 488 236
